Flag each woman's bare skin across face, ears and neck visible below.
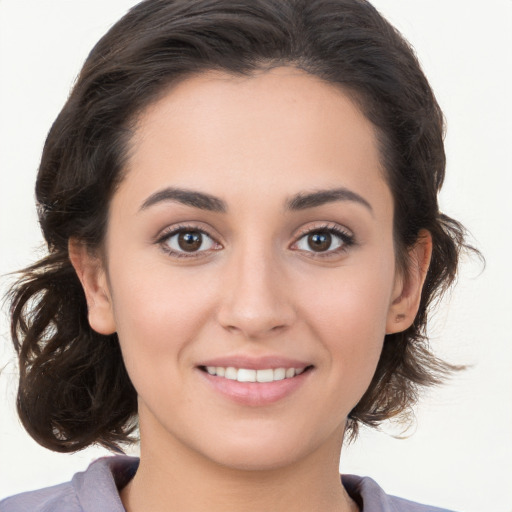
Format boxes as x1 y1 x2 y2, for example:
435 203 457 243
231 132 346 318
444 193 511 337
70 67 431 512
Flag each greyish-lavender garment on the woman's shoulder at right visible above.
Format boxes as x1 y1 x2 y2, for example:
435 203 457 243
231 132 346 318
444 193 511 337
341 475 460 512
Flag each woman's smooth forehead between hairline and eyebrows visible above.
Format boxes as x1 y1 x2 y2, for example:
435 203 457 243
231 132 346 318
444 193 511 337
120 67 390 212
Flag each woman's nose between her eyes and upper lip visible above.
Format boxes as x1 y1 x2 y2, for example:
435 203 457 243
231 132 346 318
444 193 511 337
218 244 296 339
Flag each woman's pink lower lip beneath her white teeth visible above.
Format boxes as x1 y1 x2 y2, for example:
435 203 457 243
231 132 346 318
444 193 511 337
198 369 312 407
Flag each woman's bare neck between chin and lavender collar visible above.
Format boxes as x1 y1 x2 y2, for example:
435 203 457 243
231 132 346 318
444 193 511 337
121 418 358 512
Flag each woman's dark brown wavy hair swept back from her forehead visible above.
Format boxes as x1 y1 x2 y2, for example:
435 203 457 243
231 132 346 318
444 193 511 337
11 0 472 451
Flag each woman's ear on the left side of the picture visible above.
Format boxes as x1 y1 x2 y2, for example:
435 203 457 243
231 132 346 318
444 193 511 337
68 239 116 335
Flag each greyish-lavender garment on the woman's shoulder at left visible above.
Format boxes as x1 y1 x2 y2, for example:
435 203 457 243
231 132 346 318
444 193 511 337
0 456 138 512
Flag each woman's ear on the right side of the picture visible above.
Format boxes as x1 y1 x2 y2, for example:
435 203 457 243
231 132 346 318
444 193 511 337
386 229 432 334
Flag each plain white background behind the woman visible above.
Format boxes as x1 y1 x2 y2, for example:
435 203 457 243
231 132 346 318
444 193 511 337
0 0 512 512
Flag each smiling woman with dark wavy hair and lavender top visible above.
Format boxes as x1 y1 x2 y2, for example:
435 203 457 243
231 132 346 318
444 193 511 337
1 0 476 512
